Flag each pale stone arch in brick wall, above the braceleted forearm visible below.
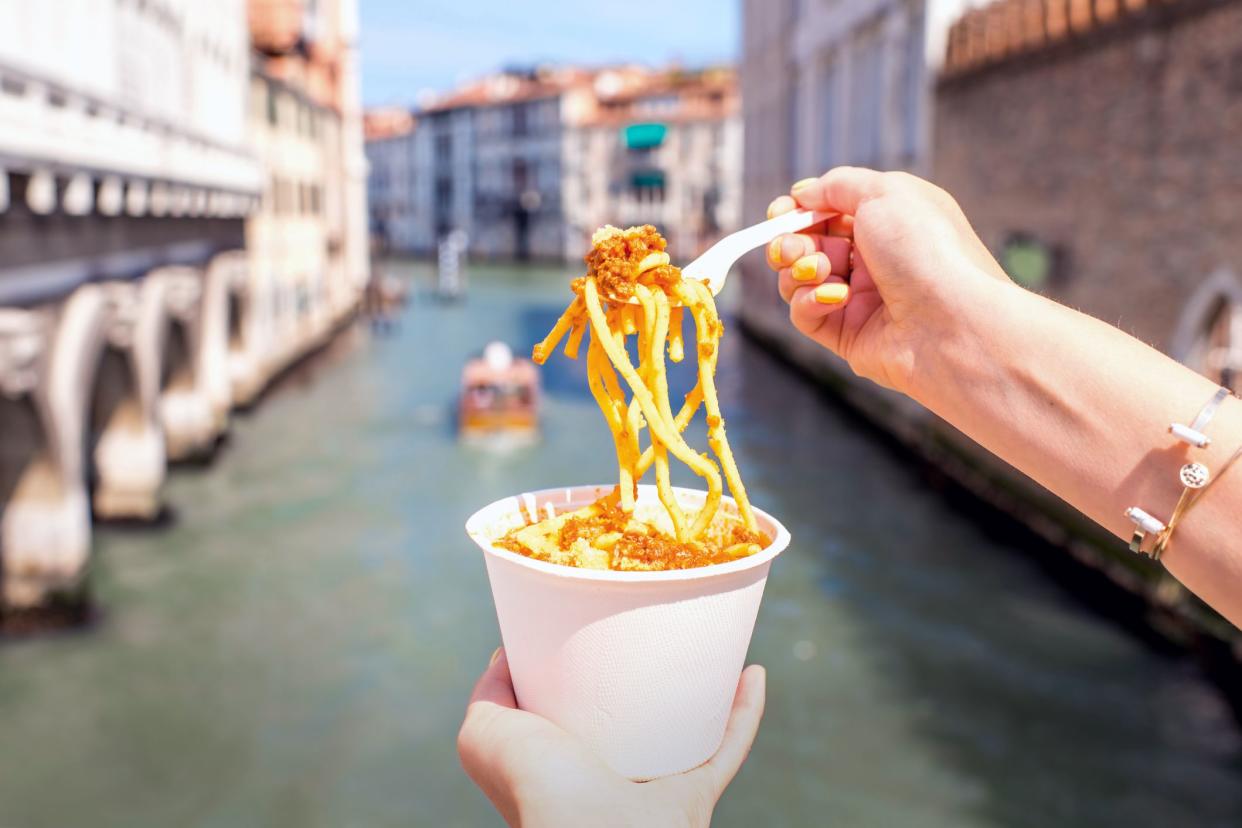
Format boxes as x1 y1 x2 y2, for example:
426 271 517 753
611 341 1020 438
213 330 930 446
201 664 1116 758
1170 268 1242 390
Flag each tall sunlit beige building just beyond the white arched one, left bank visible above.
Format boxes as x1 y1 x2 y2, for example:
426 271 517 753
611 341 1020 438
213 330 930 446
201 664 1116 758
242 0 370 401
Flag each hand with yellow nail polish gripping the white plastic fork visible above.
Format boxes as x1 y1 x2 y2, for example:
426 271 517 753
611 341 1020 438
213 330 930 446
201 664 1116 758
768 166 1012 398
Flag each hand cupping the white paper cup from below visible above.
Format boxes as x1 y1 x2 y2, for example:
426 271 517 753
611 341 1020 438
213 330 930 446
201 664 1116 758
457 650 765 827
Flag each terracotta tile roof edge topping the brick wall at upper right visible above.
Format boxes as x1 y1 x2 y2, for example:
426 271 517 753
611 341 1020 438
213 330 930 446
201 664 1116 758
944 0 1189 77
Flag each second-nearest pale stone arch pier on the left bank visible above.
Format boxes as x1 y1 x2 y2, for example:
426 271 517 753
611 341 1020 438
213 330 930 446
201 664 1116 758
87 279 169 520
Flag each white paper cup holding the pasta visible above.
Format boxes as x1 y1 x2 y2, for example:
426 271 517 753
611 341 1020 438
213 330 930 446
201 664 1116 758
466 484 789 780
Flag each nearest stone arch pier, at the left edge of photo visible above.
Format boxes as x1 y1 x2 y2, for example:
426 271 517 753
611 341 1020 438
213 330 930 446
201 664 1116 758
0 286 103 608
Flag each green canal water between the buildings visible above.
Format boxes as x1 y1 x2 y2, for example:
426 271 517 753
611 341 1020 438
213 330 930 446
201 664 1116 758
0 264 1242 828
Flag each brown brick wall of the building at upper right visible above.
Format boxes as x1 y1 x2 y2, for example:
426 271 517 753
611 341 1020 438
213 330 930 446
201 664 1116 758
934 0 1242 357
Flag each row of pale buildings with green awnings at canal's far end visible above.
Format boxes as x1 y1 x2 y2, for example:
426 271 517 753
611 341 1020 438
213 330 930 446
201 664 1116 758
369 67 741 261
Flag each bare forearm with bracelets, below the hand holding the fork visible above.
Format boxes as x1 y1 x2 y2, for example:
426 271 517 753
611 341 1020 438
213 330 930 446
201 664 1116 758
914 275 1242 623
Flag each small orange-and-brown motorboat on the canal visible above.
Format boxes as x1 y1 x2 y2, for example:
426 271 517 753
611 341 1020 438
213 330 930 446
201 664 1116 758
457 343 539 447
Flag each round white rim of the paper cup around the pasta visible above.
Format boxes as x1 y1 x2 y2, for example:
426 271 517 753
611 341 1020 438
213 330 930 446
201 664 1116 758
466 483 790 583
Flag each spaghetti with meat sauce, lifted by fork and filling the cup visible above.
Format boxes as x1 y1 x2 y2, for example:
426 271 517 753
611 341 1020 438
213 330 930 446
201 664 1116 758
496 225 771 571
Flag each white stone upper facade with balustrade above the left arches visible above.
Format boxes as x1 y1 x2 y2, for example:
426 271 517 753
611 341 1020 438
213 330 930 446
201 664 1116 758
0 0 261 304
